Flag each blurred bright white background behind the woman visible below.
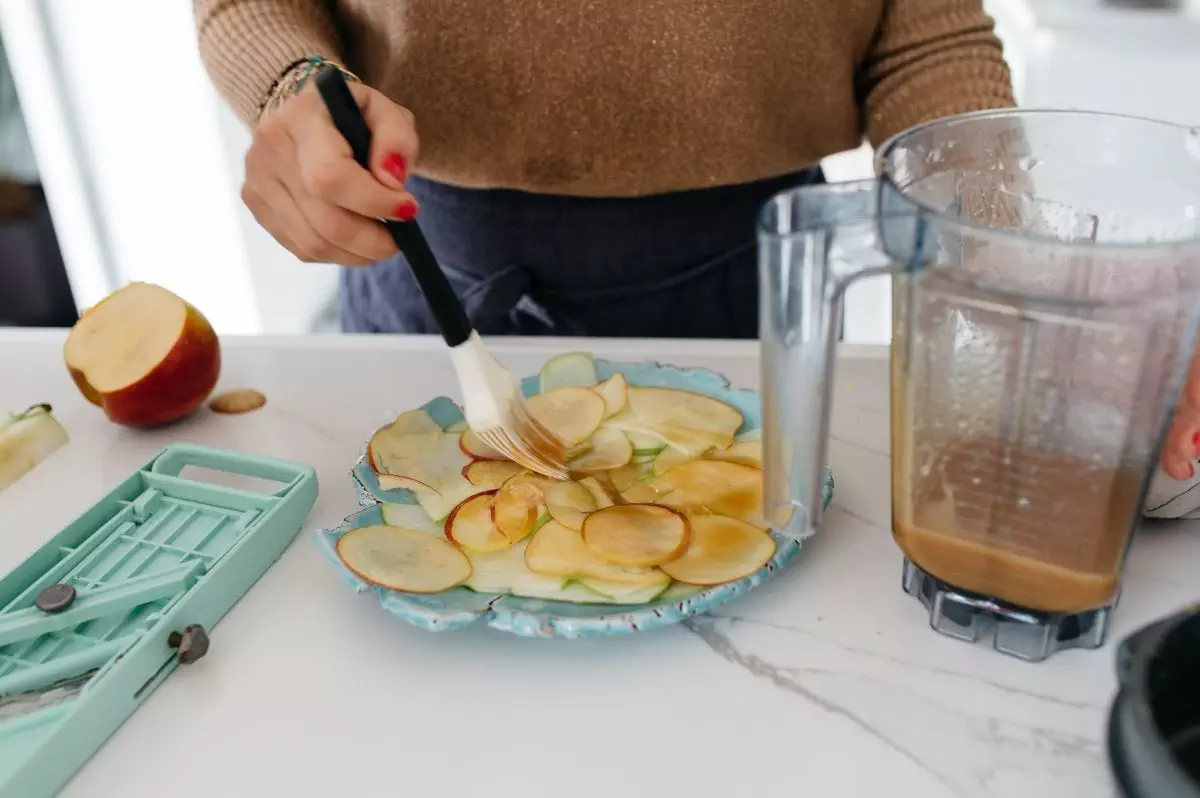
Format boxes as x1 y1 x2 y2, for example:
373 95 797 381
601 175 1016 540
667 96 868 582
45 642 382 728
0 0 1200 342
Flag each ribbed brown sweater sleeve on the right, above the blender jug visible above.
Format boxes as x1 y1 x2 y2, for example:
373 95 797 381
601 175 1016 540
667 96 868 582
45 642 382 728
859 0 1016 146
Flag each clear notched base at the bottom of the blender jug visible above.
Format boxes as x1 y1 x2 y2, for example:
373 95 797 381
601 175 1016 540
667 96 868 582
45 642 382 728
904 558 1116 662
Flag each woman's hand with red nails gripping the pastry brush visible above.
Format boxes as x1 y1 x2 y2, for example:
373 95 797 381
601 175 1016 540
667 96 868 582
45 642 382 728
241 80 418 266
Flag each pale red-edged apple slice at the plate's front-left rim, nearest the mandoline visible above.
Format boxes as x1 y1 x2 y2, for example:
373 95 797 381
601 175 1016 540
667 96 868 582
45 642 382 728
336 523 472 593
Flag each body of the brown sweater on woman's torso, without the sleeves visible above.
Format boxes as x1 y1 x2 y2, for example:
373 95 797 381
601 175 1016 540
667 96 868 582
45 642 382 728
337 0 883 196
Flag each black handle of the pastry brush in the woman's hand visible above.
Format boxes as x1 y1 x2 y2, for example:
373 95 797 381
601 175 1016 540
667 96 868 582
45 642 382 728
317 70 472 347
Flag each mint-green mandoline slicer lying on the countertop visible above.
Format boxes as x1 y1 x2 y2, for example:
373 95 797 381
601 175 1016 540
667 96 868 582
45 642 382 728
0 444 317 798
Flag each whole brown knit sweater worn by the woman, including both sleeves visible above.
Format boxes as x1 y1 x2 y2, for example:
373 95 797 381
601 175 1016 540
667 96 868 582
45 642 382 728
194 0 1013 196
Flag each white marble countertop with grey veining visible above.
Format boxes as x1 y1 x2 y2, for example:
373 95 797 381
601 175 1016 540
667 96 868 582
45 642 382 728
0 330 1200 798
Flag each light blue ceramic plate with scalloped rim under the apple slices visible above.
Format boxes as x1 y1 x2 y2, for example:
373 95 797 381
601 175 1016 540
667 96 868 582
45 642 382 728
317 359 833 638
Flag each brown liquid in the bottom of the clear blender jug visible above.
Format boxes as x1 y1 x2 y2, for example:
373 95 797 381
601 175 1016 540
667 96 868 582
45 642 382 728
892 419 1142 612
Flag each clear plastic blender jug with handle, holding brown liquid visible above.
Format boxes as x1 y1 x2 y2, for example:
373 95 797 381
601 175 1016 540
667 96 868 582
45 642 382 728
758 110 1200 660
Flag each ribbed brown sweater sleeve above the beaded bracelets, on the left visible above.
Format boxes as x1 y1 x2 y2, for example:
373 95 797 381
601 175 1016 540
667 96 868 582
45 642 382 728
192 0 340 125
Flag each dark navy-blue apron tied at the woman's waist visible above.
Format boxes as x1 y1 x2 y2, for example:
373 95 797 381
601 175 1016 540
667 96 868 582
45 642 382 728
341 167 824 338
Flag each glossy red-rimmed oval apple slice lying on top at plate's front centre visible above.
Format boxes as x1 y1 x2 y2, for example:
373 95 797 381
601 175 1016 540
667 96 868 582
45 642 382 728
582 504 688 568
